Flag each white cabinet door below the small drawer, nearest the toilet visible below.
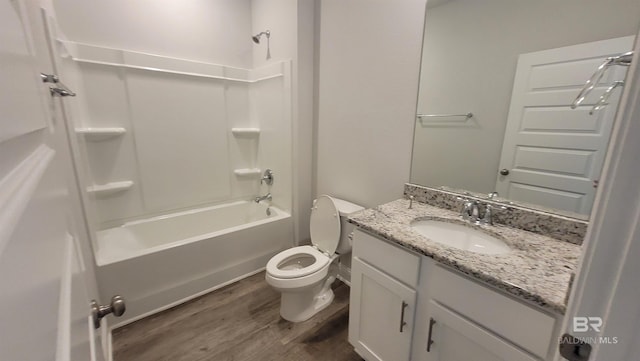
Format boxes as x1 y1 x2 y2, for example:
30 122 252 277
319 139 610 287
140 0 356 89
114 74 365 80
349 257 416 361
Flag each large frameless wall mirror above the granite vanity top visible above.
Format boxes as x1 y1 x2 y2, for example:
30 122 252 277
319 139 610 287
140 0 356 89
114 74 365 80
410 0 640 219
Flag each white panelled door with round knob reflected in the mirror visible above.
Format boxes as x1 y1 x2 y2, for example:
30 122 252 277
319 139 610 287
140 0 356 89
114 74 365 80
496 36 633 215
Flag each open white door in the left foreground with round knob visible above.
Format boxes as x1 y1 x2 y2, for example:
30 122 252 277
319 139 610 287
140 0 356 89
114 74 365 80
0 0 104 361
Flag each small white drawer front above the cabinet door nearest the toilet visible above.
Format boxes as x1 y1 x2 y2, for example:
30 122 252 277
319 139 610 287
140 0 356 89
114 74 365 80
353 230 420 288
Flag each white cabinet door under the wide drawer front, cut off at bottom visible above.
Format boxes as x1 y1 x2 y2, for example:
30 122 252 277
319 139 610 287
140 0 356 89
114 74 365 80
420 300 539 361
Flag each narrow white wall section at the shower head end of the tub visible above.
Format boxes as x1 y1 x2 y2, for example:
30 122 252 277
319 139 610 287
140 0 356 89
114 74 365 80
251 0 315 241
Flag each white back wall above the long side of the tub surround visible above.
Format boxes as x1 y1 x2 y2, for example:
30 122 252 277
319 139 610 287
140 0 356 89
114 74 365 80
53 0 253 68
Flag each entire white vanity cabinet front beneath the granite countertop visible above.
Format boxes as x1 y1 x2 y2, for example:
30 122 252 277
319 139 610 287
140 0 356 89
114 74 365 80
349 230 562 361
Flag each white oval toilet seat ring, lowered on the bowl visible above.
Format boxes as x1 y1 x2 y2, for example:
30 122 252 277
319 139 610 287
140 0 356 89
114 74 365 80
267 246 330 279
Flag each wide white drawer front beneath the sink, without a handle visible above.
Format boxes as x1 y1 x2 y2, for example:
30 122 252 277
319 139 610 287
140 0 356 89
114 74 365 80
429 266 556 359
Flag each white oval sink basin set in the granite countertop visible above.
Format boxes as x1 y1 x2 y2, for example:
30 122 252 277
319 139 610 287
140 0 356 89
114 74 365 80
411 219 511 254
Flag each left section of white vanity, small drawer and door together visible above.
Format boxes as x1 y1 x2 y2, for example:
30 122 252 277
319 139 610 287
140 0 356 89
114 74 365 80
349 232 420 361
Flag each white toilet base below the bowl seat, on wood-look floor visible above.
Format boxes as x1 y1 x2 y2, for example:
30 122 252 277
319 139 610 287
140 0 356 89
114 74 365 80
280 277 335 322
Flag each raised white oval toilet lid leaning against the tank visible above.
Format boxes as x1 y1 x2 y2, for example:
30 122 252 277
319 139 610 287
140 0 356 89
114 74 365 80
309 195 340 254
